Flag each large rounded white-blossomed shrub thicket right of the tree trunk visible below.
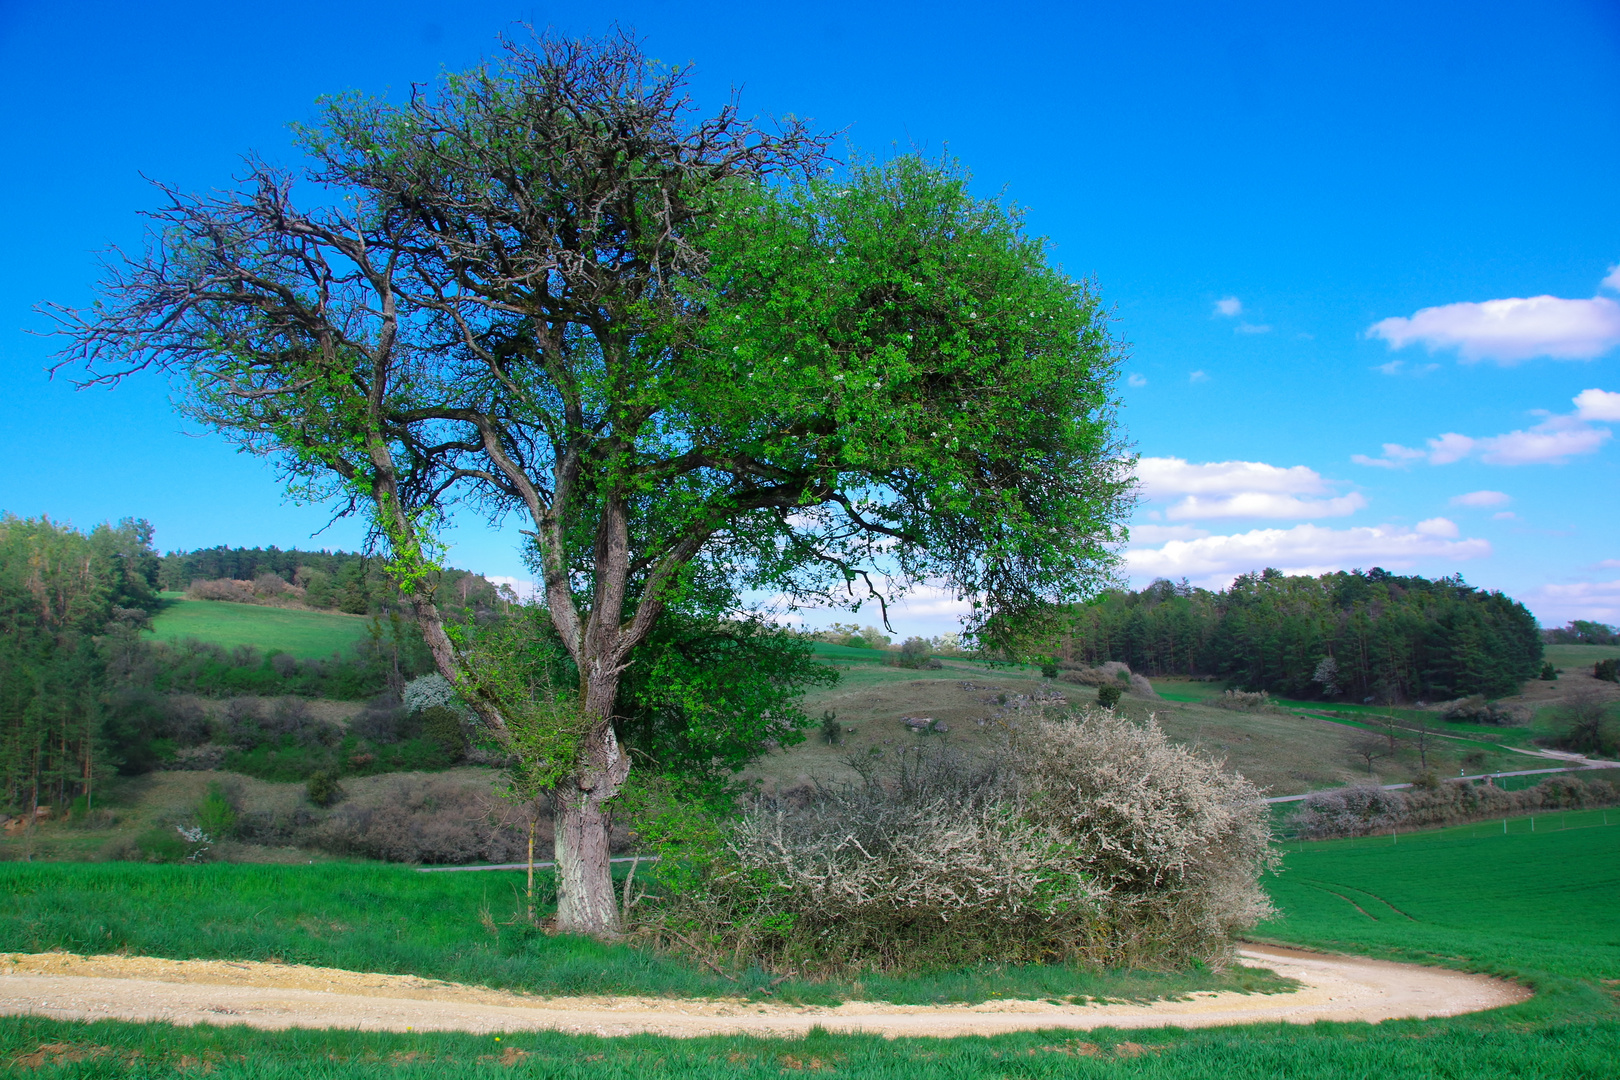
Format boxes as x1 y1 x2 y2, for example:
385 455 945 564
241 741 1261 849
654 712 1272 972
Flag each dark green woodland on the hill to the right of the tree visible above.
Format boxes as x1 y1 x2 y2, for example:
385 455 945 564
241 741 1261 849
1050 567 1542 701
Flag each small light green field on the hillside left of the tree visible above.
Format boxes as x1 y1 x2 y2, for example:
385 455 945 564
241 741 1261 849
151 593 368 659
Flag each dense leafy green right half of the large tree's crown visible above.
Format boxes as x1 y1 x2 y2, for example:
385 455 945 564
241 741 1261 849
687 155 1129 650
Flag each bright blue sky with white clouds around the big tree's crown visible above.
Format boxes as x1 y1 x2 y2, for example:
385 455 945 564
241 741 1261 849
0 0 1620 633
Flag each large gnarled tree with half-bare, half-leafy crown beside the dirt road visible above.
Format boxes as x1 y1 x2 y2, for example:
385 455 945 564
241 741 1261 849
44 36 1129 933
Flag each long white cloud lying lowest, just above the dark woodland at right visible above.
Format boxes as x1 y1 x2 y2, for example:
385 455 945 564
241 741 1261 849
1124 518 1490 585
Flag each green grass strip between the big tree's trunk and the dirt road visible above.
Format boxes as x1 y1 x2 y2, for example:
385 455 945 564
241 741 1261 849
0 863 1288 1004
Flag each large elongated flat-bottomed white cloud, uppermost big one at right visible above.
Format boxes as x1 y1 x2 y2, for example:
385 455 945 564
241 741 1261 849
1367 296 1620 364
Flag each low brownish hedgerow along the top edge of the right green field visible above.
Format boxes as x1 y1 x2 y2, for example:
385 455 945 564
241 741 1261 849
1291 774 1620 840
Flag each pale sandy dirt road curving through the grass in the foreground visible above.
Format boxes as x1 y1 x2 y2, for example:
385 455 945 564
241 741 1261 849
0 946 1529 1036
